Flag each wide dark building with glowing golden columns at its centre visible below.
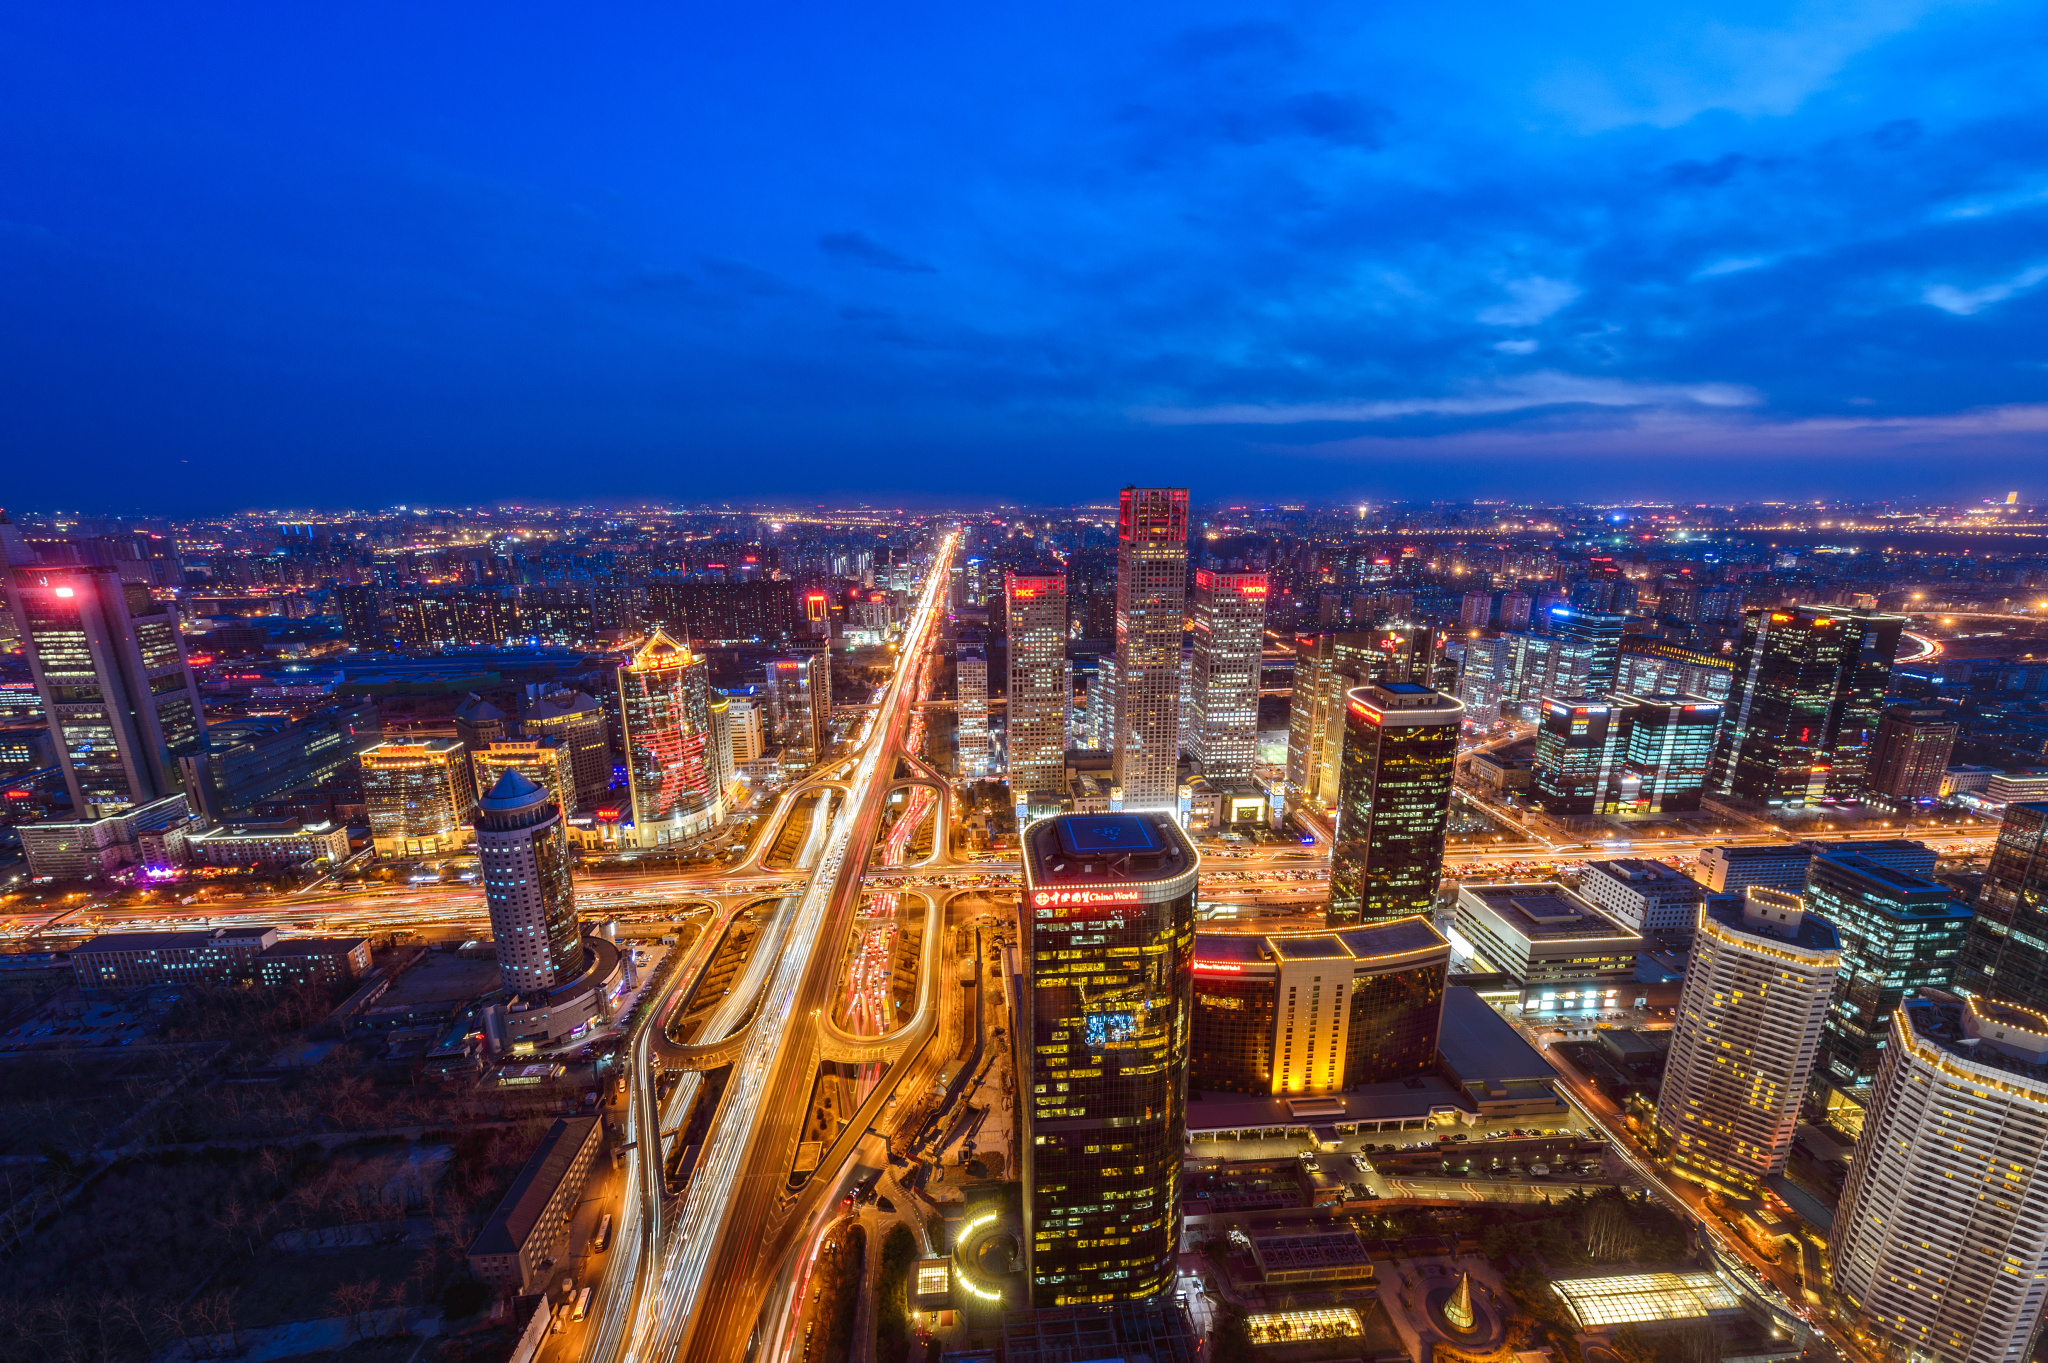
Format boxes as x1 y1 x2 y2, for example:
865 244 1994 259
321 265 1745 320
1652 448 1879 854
1188 919 1450 1095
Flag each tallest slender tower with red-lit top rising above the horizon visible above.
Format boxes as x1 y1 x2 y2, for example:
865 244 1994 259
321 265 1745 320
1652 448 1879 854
1114 487 1188 808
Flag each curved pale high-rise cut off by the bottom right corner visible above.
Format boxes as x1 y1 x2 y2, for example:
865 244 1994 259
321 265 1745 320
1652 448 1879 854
1829 993 2048 1363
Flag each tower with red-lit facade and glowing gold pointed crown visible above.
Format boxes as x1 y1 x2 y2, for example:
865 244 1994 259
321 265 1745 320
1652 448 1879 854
618 630 725 847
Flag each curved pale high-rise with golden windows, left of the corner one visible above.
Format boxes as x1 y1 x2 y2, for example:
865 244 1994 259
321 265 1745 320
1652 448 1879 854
1657 886 1841 1195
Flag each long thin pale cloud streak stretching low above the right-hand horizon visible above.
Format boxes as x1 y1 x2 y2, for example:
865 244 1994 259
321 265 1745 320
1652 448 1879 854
1133 370 1763 426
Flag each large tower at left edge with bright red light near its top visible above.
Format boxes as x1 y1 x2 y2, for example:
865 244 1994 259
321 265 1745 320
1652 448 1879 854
6 546 205 819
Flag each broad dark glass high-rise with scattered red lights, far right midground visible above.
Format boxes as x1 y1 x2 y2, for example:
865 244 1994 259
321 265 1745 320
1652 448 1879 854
1712 606 1905 806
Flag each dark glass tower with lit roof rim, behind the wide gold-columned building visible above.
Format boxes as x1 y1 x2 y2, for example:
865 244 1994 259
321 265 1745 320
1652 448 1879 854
1329 682 1464 925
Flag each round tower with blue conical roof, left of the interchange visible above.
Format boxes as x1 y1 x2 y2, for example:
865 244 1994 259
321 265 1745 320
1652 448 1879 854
477 767 584 997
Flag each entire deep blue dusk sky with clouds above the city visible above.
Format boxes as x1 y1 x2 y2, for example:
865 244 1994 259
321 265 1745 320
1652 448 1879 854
0 0 2048 510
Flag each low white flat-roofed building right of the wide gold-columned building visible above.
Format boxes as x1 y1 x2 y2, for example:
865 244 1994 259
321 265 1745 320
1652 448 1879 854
1452 882 1642 1013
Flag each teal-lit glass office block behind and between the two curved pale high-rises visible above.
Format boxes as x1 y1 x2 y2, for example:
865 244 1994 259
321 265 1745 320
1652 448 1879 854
1806 851 1970 1095
